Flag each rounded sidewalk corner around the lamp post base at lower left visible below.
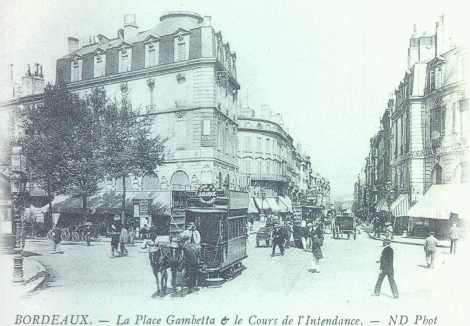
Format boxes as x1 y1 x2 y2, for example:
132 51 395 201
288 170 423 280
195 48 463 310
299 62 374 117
0 255 48 298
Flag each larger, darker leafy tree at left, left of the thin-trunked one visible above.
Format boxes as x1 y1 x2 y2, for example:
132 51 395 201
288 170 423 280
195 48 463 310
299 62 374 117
19 84 102 221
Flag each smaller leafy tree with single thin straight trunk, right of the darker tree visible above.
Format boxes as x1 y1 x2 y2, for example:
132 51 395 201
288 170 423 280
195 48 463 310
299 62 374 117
100 90 166 224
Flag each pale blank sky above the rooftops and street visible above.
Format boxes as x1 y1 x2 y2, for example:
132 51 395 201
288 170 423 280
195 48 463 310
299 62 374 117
0 0 470 198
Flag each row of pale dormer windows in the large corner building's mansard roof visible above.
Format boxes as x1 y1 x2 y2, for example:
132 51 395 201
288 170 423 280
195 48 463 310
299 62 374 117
70 34 235 82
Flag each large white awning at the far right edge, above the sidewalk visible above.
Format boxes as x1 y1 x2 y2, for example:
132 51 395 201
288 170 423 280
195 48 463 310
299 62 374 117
407 184 470 220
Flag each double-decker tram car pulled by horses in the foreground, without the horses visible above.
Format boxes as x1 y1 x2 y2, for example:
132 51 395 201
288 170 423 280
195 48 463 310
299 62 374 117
170 185 248 285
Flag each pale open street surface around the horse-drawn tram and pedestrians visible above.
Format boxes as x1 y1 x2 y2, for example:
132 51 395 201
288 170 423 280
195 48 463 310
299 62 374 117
1 230 468 325
